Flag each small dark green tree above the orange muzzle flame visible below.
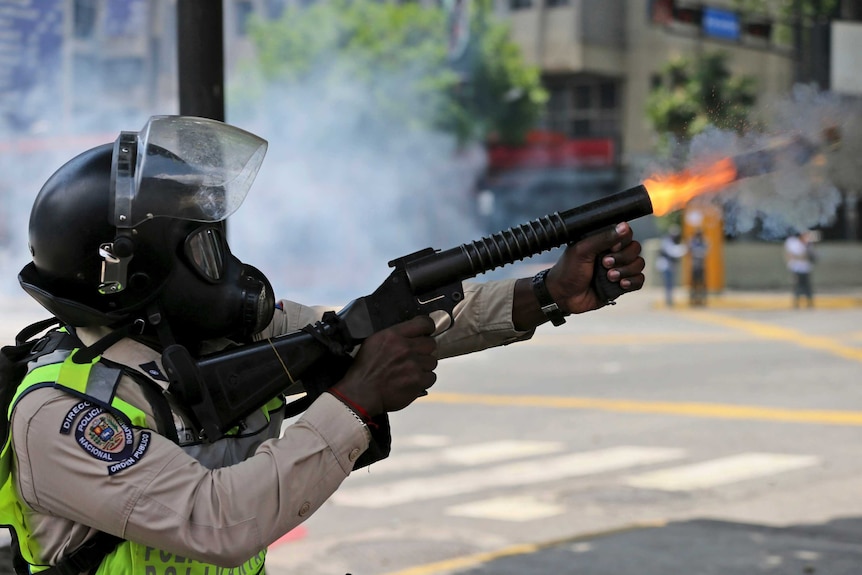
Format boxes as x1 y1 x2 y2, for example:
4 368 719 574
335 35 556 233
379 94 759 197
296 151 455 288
646 52 756 143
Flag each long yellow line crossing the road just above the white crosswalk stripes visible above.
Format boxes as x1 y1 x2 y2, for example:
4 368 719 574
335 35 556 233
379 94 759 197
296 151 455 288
420 389 862 425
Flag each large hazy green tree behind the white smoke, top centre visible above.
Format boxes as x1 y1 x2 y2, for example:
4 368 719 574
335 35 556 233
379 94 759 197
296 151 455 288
243 0 547 143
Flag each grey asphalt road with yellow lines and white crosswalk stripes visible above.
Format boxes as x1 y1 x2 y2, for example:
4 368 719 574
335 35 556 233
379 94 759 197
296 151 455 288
3 284 862 575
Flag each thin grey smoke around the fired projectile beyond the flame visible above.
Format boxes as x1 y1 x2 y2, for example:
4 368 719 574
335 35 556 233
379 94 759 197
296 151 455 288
648 86 862 240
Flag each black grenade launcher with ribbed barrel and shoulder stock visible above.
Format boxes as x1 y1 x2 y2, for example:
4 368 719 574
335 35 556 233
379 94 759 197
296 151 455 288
162 186 652 441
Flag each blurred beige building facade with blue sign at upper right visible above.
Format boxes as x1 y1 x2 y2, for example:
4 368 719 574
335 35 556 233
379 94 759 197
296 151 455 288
498 0 862 240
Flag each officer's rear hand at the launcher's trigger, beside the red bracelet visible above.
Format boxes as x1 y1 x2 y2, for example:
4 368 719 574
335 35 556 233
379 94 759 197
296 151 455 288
333 316 437 417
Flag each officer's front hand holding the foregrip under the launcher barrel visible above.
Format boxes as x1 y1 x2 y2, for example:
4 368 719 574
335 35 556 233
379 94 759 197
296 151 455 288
547 223 645 313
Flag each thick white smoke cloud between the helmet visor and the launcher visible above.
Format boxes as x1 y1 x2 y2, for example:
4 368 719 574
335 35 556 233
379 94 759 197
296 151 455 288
228 61 485 304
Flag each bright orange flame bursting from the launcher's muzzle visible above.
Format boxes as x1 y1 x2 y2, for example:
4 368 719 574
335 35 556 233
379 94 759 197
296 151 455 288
643 158 737 216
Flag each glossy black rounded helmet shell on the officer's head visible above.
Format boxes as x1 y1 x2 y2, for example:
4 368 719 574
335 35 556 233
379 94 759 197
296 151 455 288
19 144 181 325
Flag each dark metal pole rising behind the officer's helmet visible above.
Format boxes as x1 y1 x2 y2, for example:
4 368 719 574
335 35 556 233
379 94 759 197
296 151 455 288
177 0 225 122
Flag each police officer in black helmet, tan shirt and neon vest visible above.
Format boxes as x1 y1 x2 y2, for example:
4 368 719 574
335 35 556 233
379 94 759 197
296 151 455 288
0 116 644 575
